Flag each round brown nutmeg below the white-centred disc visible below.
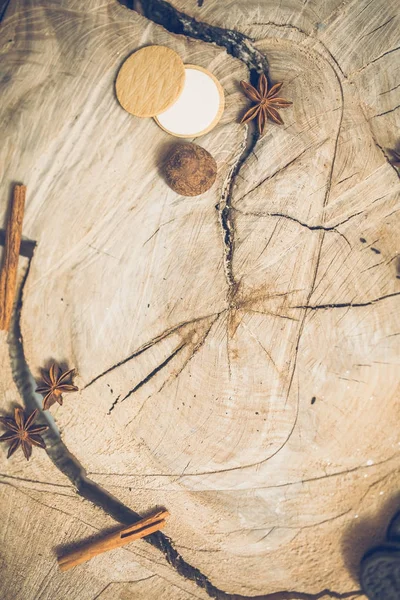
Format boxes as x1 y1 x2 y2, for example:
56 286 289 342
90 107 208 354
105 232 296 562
164 142 217 196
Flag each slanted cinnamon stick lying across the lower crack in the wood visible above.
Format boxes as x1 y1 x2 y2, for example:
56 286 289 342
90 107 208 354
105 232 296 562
57 510 169 571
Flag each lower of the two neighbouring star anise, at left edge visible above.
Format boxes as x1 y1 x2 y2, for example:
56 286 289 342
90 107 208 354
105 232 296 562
0 408 48 460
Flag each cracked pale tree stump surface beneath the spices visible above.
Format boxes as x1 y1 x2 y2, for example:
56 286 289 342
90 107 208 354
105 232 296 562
0 0 400 600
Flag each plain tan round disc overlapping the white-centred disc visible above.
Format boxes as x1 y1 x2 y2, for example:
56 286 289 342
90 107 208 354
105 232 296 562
115 46 185 117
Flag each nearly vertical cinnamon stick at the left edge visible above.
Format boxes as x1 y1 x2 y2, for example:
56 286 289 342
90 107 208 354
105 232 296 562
0 185 26 330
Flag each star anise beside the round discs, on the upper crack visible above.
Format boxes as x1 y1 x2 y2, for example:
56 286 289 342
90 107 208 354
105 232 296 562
240 73 293 135
